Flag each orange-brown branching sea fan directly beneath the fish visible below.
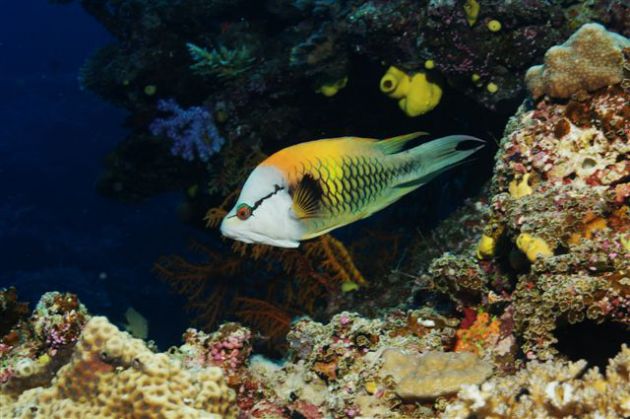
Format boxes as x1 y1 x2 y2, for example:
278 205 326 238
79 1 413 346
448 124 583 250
155 191 366 350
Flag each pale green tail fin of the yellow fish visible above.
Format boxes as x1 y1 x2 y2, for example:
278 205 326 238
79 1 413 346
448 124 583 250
397 135 485 188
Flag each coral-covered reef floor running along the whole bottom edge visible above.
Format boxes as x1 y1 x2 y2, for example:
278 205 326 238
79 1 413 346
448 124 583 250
0 293 630 418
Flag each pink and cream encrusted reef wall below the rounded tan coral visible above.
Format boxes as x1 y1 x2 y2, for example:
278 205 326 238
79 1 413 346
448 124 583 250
486 83 630 359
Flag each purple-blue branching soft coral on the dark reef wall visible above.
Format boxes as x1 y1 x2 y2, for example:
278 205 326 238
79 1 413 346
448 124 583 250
149 99 225 162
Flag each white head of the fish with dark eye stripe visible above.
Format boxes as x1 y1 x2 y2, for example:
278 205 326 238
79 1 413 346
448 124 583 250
221 166 304 248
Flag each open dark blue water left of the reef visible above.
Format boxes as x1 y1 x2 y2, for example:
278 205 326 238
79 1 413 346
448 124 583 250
0 0 194 346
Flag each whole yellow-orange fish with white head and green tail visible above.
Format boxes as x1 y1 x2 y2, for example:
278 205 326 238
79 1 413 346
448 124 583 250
220 132 485 248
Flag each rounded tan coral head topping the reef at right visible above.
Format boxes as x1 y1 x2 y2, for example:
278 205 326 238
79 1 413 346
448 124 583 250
525 23 630 98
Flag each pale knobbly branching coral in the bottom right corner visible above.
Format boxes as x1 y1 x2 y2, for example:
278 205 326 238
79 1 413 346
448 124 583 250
443 345 630 419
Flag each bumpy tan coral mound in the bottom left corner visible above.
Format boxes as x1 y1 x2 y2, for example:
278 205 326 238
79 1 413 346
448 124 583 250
0 317 236 418
